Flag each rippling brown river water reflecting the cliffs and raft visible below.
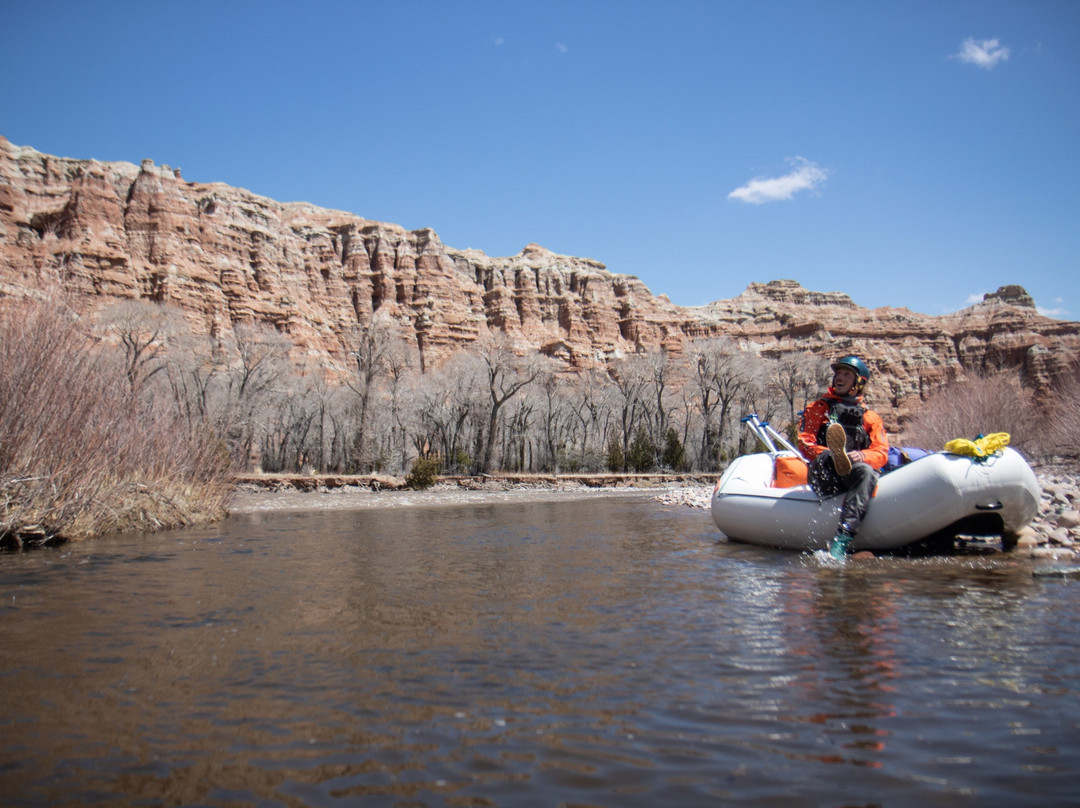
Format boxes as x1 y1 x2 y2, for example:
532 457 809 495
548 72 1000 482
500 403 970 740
0 495 1080 807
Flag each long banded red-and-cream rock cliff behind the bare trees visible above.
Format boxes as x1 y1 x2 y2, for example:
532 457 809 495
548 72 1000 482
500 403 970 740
0 137 1080 417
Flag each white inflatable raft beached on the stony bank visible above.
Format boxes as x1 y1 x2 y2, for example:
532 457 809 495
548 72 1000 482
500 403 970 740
712 416 1040 551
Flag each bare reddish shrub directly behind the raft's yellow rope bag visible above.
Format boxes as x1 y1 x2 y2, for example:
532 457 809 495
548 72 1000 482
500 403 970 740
902 371 1040 457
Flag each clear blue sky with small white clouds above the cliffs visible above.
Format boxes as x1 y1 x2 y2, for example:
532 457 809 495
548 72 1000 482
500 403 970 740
0 0 1080 320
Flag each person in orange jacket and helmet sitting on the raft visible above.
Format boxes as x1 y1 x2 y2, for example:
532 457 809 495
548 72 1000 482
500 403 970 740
798 356 889 558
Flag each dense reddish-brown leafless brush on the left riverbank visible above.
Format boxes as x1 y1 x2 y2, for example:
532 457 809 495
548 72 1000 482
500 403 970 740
0 300 231 544
